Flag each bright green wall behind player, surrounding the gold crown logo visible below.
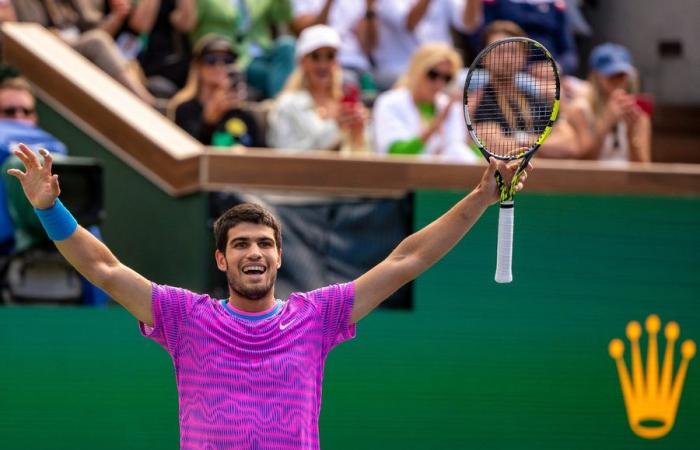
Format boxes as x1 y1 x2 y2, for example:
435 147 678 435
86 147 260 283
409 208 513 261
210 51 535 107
0 192 700 450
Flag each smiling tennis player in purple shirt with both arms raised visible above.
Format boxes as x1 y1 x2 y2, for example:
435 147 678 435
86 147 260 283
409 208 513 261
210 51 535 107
8 145 526 450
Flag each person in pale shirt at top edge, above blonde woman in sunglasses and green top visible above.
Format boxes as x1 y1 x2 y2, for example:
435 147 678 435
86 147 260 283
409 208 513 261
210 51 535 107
372 0 475 90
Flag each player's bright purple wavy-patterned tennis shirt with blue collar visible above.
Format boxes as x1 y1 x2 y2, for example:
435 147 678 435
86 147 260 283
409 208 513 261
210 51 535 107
140 283 355 450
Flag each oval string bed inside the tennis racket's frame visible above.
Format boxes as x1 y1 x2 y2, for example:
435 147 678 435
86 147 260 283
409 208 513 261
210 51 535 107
467 41 557 157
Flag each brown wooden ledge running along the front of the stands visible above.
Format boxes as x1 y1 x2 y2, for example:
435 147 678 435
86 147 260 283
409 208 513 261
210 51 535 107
2 23 700 196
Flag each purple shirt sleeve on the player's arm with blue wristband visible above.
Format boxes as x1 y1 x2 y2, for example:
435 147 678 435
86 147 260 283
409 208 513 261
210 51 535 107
139 283 195 356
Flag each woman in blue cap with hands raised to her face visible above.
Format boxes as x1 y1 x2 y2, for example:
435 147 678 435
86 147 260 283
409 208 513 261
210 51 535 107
567 43 651 162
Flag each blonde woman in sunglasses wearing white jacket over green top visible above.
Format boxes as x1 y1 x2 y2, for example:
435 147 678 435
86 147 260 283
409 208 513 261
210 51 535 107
373 43 478 161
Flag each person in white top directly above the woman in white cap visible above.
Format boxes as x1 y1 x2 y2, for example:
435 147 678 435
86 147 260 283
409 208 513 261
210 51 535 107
292 0 378 101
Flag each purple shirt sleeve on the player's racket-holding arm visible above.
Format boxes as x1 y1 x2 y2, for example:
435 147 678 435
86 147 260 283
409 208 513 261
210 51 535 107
309 282 356 355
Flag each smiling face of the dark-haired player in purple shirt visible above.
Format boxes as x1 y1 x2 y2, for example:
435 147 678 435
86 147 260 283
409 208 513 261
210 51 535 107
215 222 282 302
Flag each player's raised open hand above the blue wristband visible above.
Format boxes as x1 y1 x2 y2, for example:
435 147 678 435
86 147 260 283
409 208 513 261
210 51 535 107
7 144 61 209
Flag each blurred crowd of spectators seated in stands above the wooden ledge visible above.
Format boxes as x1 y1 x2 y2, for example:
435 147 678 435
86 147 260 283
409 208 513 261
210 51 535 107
0 0 651 162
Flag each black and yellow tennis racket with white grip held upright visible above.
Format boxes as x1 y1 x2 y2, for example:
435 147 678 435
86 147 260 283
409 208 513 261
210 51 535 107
464 38 559 283
